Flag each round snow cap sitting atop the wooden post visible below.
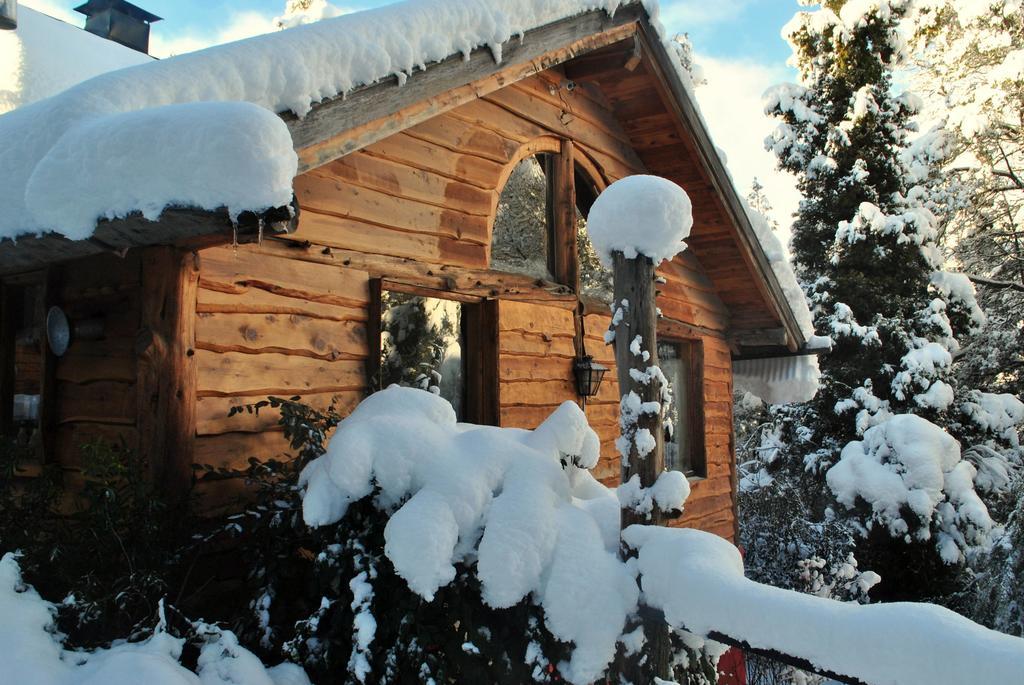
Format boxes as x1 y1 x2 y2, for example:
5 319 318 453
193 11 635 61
587 175 693 267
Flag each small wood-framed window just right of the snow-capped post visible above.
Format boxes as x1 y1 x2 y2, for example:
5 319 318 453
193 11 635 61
657 340 707 476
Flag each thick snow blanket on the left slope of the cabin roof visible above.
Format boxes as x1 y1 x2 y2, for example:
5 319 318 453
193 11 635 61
0 0 682 238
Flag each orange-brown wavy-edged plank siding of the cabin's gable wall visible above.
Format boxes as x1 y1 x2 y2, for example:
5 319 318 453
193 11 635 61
186 71 733 539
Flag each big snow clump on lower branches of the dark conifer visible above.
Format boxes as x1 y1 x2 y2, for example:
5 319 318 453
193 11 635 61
825 414 994 563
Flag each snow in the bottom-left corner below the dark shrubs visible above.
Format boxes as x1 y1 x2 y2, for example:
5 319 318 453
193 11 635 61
0 554 309 685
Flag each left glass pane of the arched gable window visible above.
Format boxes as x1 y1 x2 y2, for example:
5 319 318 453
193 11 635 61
490 157 554 281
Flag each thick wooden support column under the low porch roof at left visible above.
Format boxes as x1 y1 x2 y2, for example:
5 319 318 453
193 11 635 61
135 247 199 499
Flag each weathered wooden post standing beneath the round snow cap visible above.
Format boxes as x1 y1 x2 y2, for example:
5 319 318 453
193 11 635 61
612 252 670 683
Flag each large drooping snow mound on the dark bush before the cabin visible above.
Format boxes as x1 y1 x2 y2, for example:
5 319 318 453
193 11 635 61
300 386 643 683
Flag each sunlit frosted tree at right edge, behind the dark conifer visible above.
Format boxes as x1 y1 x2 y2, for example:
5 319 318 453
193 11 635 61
910 0 1024 395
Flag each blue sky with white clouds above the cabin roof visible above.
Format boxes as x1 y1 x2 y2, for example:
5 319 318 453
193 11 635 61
22 0 801 229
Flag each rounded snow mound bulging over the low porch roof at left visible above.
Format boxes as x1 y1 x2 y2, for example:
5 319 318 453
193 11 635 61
25 102 298 240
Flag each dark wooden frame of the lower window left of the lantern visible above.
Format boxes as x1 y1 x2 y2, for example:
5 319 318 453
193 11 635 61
367 279 501 426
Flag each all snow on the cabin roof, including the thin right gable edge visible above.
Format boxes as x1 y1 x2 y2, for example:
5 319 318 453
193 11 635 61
0 0 807 346
